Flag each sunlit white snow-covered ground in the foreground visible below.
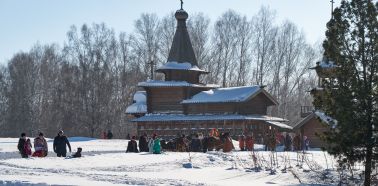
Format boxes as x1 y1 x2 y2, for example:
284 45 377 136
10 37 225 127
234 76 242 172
0 137 364 186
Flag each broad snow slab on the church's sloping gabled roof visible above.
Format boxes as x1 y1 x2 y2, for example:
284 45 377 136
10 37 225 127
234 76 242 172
181 86 261 103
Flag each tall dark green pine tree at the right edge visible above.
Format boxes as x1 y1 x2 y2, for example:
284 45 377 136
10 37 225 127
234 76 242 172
314 0 378 185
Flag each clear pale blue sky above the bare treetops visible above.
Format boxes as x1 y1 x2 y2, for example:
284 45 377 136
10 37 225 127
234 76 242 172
0 0 341 64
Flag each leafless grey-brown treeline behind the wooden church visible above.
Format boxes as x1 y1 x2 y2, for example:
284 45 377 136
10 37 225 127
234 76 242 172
0 7 321 137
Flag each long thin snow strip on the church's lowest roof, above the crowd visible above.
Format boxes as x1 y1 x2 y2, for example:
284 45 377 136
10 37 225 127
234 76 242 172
133 114 287 122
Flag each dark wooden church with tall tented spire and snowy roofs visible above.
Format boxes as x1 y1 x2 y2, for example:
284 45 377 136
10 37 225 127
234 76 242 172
126 8 292 138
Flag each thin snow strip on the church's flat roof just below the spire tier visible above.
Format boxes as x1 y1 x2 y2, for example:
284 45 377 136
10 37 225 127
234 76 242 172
138 80 219 88
